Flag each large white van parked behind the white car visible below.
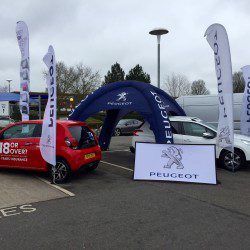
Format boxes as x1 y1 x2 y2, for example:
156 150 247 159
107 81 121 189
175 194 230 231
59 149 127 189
176 93 243 132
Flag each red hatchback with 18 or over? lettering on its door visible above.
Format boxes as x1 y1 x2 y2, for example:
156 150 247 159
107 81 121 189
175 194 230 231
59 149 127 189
0 120 101 183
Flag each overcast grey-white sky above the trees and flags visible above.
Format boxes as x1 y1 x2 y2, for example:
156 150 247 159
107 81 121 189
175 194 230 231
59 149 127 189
0 0 250 93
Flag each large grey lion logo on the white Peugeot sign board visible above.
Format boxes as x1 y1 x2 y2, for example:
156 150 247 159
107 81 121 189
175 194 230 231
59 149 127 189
161 146 184 169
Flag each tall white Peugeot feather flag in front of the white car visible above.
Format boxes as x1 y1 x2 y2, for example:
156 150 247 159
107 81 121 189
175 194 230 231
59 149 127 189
205 24 234 152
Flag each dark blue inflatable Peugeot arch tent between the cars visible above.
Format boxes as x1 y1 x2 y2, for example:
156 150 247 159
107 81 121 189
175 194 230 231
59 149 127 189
69 81 186 150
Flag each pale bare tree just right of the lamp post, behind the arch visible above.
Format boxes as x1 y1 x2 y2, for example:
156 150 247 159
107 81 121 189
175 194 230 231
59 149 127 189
163 73 190 98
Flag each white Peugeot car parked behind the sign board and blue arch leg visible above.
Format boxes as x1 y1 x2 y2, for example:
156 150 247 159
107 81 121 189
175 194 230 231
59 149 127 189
130 116 250 170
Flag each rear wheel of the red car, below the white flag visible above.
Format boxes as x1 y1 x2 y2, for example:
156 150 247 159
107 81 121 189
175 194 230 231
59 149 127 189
50 159 71 184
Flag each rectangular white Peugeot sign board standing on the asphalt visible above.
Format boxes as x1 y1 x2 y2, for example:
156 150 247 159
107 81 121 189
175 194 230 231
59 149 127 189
134 143 216 184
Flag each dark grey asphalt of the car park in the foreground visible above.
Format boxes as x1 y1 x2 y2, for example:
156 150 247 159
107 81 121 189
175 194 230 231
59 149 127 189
0 137 250 249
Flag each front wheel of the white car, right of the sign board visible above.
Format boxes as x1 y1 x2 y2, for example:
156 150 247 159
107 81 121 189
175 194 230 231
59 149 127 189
220 149 245 171
